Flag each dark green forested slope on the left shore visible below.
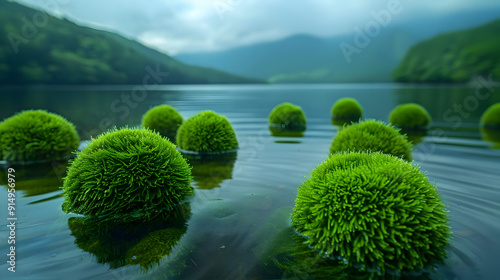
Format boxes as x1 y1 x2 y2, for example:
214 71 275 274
0 0 256 85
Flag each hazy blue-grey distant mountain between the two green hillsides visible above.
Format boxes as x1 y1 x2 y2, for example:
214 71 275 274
175 10 500 83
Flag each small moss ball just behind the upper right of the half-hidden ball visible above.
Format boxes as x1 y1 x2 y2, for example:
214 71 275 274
389 103 431 129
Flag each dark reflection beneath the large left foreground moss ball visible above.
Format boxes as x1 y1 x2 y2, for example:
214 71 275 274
68 204 190 273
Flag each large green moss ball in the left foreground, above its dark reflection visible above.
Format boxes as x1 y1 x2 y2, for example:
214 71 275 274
62 128 193 221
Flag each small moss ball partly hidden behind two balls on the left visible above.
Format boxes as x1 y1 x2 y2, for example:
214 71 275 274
142 105 183 142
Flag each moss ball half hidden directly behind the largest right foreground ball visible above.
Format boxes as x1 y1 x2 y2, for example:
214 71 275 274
330 120 412 161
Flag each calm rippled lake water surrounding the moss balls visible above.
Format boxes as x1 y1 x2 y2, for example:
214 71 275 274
0 84 500 280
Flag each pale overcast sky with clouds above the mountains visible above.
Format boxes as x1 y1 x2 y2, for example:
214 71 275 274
13 0 500 55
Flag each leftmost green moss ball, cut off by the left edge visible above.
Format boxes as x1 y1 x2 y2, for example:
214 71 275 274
0 110 80 162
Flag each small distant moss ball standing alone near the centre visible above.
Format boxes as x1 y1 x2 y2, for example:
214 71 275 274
269 102 307 132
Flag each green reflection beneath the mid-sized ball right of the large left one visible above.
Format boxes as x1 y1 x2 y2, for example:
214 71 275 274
183 152 237 190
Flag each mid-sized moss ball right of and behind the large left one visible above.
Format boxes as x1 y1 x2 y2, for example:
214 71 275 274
176 111 238 153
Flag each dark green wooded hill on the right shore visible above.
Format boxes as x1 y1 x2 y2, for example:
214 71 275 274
393 20 500 82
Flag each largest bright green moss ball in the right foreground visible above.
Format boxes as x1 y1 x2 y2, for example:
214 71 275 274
292 152 450 271
